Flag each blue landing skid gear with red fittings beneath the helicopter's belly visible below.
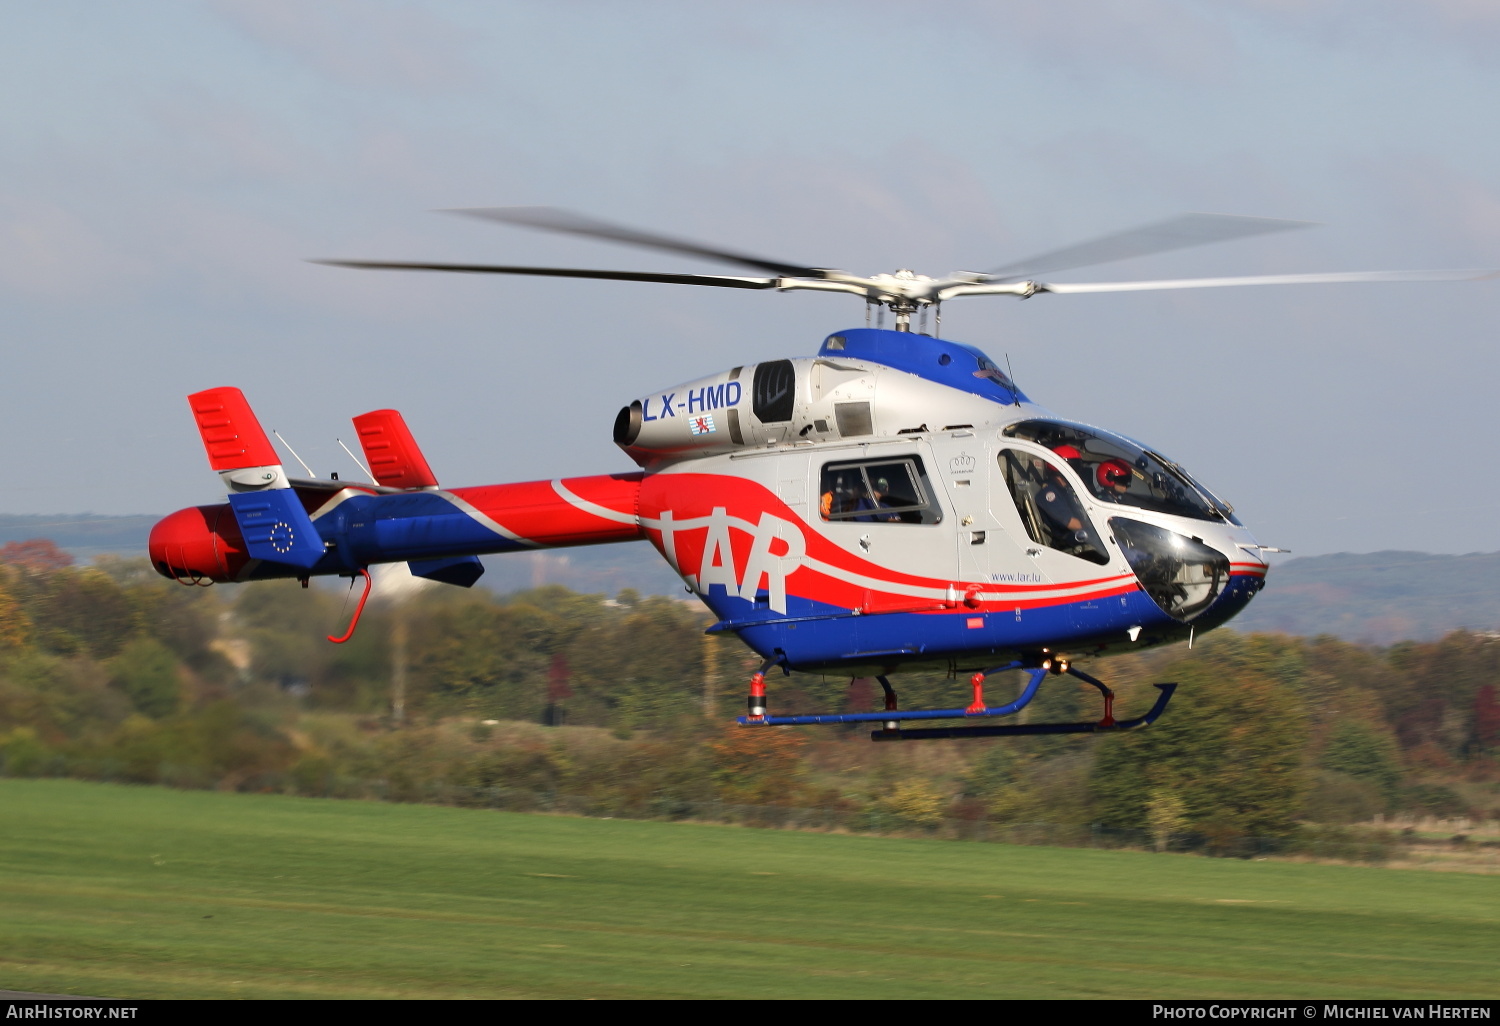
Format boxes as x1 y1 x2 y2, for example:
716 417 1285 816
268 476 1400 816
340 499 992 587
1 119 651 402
738 659 1178 741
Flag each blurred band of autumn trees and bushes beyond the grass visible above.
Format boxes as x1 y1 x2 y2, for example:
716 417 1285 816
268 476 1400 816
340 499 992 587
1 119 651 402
0 542 1500 852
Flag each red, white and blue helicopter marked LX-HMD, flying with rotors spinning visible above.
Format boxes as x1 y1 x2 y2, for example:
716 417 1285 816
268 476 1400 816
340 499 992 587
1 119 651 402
149 207 1500 741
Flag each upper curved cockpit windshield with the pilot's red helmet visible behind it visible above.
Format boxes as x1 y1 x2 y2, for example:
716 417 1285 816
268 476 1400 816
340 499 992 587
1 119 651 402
1004 420 1239 525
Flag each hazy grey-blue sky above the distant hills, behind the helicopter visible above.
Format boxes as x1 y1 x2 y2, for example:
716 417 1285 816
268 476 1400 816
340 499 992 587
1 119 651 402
0 0 1500 555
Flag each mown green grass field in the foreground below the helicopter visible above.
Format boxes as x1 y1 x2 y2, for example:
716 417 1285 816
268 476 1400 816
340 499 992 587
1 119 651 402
0 780 1500 998
